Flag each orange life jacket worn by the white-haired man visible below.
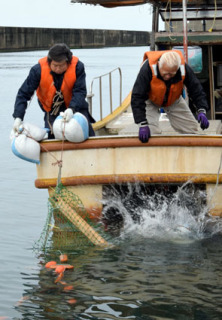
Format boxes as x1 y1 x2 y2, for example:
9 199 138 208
143 50 185 107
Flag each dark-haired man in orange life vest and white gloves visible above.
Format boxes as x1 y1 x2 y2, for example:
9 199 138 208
13 43 95 139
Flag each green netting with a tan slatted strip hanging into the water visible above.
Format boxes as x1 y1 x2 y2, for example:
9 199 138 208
34 183 109 251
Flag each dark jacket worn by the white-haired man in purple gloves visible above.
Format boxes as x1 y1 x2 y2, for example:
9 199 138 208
131 60 209 123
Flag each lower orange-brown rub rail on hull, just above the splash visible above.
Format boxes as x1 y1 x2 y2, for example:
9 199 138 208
35 174 222 189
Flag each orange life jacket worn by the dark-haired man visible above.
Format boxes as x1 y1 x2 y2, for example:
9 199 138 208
36 57 79 112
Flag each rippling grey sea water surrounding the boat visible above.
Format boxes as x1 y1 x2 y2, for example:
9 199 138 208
0 47 222 320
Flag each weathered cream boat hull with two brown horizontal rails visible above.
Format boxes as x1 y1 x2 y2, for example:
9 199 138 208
35 136 222 216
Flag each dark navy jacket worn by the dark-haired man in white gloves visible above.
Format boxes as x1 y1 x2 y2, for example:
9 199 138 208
12 61 95 138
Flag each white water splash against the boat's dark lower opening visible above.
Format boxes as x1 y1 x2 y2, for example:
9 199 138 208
103 181 222 241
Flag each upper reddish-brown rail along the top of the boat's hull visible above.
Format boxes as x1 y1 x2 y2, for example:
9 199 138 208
40 136 222 152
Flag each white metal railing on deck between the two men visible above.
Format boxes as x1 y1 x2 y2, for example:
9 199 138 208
87 67 122 120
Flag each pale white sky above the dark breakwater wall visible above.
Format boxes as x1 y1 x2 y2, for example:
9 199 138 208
0 0 163 31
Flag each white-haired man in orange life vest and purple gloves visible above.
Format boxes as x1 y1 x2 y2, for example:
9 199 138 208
131 50 209 142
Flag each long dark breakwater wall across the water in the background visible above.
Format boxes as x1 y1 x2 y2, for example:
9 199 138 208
0 27 151 52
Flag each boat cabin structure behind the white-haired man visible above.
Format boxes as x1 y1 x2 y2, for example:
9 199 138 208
151 0 222 120
